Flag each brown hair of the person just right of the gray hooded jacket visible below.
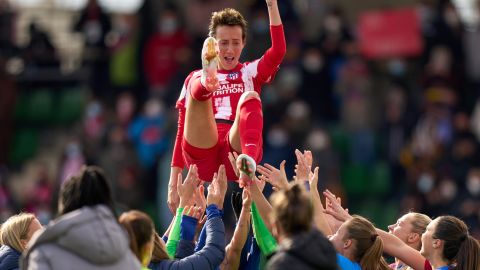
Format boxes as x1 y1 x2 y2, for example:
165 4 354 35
118 210 155 262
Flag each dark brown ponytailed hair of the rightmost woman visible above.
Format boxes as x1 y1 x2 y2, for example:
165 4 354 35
432 216 480 269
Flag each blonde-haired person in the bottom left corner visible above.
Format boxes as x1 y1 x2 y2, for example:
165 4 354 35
0 213 42 270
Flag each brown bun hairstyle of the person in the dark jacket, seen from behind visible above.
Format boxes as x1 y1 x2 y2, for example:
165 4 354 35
271 184 313 236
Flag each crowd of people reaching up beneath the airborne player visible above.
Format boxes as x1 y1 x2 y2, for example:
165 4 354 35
6 150 480 270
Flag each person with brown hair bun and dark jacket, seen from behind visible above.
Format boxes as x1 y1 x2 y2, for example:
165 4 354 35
267 184 337 270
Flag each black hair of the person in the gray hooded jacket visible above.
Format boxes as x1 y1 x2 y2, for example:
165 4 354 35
58 166 115 215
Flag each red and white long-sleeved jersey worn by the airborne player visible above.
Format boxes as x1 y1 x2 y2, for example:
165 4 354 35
172 25 286 168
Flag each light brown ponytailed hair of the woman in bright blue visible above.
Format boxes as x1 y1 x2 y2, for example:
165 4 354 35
343 216 390 270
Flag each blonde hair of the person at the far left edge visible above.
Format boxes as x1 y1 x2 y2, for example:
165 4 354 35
0 213 36 252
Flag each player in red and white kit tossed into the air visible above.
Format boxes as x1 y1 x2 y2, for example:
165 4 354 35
168 0 286 211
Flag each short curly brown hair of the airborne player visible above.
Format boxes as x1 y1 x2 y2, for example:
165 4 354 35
208 8 247 42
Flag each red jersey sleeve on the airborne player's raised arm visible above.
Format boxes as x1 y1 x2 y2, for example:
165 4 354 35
256 25 287 84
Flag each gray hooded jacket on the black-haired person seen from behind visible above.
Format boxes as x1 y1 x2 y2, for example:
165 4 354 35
21 205 141 270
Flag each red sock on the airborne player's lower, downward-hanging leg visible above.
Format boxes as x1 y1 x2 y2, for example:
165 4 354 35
240 98 263 163
